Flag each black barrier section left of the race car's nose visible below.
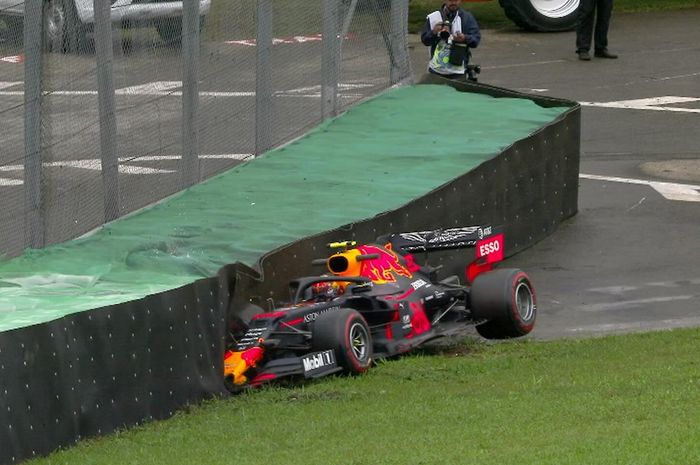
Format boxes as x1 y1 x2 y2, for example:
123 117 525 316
0 278 228 464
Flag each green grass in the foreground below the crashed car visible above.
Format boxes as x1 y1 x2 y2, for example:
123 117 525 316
29 329 700 465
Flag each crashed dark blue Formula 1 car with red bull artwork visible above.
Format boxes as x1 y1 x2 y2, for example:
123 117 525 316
224 226 537 391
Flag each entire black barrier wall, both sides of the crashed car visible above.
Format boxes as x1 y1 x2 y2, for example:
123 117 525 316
0 77 580 464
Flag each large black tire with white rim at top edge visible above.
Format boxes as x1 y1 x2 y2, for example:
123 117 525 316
499 0 580 32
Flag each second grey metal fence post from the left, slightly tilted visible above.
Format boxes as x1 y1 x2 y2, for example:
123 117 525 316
93 0 119 222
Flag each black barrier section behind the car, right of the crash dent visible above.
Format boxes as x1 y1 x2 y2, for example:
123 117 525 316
227 80 581 322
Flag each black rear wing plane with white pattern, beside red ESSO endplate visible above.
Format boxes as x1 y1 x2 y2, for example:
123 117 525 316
377 226 495 253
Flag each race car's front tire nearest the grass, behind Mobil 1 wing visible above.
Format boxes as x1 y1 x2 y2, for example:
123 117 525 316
313 308 372 374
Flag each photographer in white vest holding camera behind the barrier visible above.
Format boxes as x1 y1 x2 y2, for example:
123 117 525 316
421 0 481 81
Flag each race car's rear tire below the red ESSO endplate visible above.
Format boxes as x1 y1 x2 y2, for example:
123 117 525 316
470 269 537 339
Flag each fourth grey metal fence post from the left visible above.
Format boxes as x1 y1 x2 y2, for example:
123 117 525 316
255 0 273 155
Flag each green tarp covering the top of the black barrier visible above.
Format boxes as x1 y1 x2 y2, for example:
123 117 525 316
0 85 568 331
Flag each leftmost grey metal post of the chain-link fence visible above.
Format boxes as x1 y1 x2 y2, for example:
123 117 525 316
24 0 45 248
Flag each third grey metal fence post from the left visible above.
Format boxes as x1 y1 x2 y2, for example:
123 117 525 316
182 0 200 187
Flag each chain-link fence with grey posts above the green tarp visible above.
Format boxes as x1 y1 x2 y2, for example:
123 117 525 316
0 0 411 257
